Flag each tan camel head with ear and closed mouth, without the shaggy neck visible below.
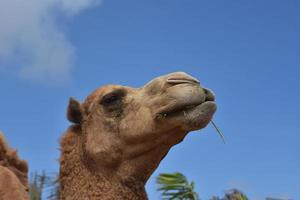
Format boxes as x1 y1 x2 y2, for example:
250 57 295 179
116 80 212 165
67 72 216 182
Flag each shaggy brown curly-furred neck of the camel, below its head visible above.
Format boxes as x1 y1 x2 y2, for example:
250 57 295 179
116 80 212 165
60 127 147 200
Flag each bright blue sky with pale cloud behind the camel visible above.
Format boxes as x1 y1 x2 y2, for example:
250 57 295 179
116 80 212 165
0 0 300 200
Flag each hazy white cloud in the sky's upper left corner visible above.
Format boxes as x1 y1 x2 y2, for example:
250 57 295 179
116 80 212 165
0 0 101 82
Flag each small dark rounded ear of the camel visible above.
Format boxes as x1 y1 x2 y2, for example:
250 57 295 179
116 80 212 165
67 97 83 124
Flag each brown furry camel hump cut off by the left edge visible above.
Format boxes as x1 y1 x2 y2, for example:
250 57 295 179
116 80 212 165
0 132 29 200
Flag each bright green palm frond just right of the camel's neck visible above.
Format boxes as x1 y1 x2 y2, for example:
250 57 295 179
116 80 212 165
157 172 199 200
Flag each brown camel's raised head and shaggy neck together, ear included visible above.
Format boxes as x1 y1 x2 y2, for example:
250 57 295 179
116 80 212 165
59 72 216 200
